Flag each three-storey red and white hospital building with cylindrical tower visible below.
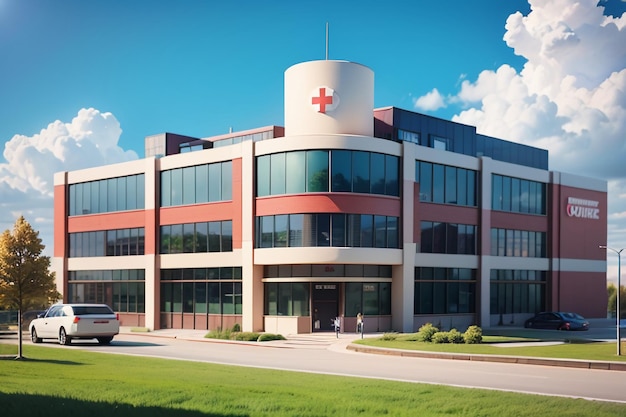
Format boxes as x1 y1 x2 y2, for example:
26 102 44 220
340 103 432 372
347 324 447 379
53 61 607 334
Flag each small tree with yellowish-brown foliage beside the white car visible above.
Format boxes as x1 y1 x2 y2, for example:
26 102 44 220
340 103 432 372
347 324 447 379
0 216 61 359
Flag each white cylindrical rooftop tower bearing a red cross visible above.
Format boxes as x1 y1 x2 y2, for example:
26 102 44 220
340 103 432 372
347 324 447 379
285 61 374 137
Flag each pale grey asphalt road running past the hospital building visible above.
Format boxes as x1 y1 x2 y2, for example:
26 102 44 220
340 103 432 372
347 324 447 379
11 330 626 403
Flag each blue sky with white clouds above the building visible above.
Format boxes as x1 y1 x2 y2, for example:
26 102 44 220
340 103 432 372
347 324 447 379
0 0 626 282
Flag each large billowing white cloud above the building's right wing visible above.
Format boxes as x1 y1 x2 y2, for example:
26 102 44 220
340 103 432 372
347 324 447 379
424 0 626 282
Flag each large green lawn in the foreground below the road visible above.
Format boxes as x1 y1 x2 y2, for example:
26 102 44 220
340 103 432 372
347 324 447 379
0 344 626 417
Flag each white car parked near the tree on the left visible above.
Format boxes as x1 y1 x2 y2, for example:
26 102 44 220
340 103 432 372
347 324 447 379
28 304 120 345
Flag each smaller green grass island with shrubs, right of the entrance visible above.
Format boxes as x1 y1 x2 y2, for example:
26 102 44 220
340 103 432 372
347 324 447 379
354 334 626 362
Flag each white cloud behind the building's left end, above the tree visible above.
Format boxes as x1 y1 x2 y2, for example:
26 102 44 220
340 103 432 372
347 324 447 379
0 108 138 256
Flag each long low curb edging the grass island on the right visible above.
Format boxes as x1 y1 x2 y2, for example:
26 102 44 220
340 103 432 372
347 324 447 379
346 343 626 371
